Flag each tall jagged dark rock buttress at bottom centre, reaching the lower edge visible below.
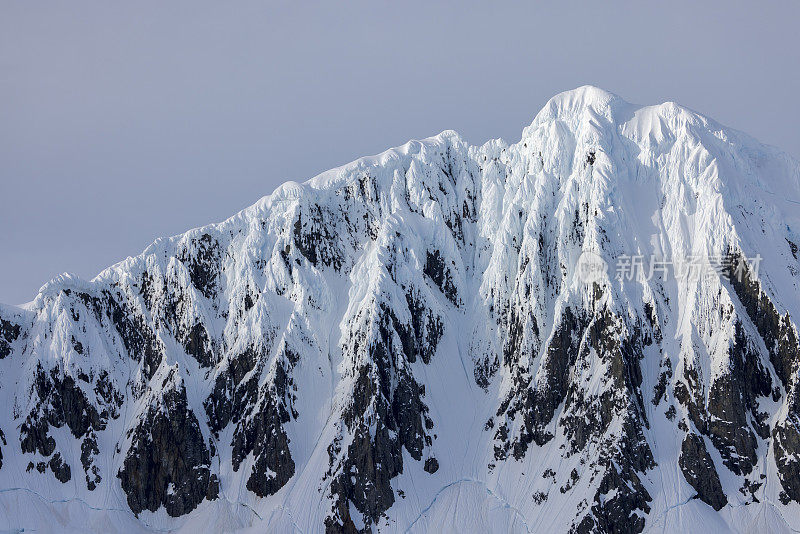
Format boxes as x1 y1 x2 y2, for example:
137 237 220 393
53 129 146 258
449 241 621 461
326 298 439 532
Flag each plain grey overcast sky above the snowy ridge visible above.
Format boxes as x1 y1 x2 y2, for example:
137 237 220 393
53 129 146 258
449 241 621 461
0 0 800 303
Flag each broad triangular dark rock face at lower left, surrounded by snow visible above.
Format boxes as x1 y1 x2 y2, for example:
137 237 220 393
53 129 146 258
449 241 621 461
117 378 219 517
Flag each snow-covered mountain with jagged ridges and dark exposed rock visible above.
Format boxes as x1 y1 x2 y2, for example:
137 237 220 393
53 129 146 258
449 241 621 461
0 87 800 532
